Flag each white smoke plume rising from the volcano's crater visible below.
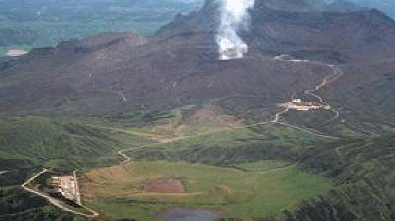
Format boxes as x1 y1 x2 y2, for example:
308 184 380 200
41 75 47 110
216 0 254 60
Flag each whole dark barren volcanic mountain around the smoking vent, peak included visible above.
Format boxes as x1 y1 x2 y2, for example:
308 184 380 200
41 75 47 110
0 0 395 131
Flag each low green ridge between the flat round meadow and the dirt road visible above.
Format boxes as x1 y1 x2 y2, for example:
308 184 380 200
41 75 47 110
125 121 334 164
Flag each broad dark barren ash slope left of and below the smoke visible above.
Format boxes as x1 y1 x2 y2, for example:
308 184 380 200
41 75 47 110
2 30 330 114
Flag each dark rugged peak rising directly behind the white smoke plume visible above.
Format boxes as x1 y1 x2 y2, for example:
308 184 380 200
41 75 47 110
156 1 395 61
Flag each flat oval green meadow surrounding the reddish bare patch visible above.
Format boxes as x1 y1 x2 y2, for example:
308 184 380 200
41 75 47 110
85 161 331 220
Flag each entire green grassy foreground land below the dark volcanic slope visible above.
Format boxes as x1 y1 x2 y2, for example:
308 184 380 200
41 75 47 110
0 101 394 220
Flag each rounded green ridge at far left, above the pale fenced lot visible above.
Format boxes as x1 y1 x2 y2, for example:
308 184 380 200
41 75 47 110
0 116 122 185
